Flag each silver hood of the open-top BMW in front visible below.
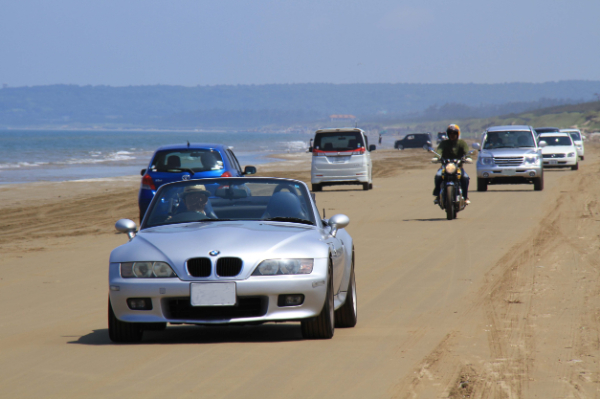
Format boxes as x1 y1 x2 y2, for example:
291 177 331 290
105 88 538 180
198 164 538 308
110 221 329 280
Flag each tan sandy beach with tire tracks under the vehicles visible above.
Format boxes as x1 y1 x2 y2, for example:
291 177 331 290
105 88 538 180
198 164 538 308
0 148 600 399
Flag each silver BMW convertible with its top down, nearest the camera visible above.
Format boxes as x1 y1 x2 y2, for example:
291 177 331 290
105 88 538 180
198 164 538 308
108 177 357 342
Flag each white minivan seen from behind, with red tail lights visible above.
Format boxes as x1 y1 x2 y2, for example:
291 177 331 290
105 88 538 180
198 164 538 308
309 128 375 191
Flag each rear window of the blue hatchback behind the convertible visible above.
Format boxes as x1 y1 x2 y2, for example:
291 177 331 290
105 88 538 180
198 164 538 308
152 149 223 173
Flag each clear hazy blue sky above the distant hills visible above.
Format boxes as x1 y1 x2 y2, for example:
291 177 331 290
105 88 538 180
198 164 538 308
0 0 600 86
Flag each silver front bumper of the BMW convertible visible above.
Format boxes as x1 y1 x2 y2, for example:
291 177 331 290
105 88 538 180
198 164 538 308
109 259 327 324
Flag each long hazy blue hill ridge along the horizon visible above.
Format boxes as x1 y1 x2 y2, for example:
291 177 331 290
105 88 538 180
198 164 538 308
0 81 600 129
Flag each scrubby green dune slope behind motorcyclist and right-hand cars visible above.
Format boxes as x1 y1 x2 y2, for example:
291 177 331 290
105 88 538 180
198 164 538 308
386 101 600 137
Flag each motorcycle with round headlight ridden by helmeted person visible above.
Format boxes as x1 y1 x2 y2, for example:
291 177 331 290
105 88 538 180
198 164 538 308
423 145 474 220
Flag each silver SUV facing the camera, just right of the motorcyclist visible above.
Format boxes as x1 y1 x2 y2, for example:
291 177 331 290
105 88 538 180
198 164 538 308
473 126 546 191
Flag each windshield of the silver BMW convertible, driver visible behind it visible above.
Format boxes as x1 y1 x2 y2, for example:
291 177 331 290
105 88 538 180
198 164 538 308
143 178 315 227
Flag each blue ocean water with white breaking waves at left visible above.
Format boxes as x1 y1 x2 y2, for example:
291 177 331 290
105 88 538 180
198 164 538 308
0 130 312 184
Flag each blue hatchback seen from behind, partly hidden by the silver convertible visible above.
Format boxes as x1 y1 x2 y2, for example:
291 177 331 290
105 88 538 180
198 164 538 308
138 143 256 222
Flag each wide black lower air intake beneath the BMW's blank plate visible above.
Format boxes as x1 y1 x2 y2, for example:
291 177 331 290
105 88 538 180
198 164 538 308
163 296 269 320
